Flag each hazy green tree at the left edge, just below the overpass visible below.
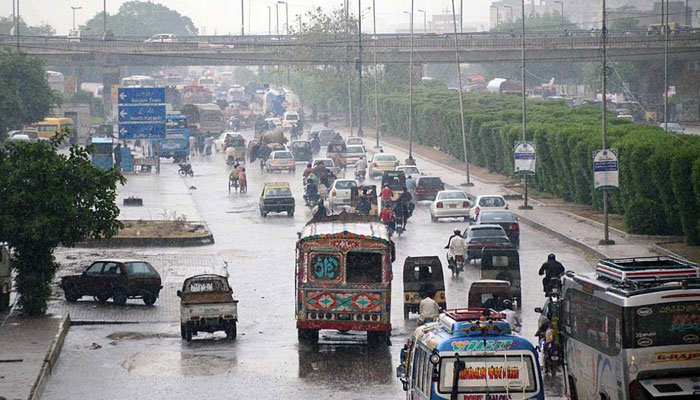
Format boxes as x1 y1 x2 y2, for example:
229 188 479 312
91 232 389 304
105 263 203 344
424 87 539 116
0 51 60 141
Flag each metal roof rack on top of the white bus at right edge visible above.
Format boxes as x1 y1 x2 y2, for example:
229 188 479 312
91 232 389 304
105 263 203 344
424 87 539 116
596 256 700 284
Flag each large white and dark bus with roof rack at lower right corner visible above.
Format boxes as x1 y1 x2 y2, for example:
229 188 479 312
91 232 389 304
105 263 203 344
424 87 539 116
559 256 700 400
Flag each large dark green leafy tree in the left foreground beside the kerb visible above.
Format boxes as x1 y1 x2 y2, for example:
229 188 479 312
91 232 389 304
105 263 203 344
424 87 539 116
0 138 125 315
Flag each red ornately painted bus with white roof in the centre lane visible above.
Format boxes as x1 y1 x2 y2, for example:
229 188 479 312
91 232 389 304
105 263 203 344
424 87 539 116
296 212 395 344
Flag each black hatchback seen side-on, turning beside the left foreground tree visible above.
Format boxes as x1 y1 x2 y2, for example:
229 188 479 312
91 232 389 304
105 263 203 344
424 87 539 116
60 259 163 306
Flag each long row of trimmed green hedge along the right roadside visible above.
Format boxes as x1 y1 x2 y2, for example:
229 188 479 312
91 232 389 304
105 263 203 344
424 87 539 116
379 88 700 245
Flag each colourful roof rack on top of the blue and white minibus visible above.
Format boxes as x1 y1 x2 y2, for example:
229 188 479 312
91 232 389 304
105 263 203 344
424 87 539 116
440 307 510 336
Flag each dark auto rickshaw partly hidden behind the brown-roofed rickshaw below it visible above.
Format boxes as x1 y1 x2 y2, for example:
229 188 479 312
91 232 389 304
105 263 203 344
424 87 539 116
481 248 522 308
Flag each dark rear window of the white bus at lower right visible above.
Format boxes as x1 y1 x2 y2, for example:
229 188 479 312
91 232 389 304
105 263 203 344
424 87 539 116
625 301 700 348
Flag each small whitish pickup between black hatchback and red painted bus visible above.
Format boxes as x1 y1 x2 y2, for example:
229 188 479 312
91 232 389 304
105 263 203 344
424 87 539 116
177 274 238 342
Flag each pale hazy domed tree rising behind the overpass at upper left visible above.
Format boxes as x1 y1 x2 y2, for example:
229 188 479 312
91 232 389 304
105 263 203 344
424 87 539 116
80 1 197 36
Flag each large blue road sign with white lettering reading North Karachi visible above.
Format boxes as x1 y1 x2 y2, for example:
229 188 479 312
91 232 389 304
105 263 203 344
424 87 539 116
117 87 166 140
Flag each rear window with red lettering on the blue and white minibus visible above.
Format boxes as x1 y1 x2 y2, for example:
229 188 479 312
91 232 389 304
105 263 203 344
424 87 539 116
438 353 538 393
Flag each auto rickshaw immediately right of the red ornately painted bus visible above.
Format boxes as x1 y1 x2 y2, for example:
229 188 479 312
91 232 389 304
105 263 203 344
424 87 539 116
403 256 447 319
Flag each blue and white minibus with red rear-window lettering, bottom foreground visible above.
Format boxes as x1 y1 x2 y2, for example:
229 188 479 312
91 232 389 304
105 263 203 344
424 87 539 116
396 308 544 400
